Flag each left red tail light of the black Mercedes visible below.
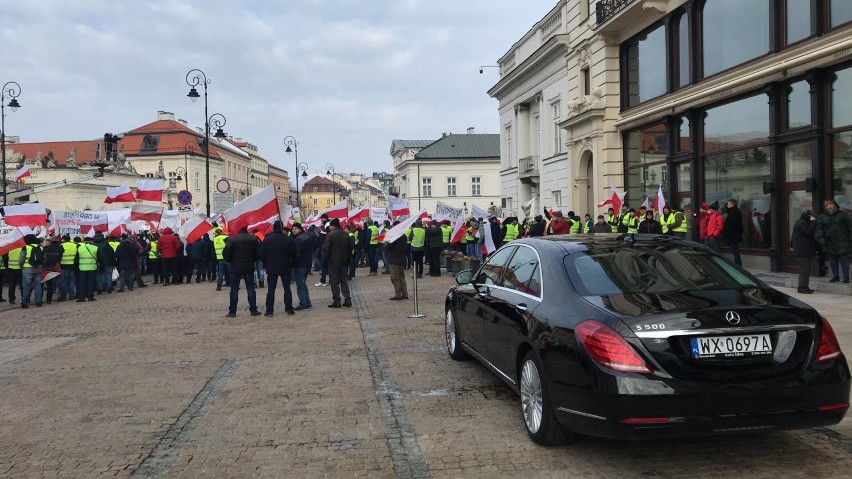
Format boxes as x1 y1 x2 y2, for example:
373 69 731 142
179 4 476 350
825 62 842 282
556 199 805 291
574 320 653 374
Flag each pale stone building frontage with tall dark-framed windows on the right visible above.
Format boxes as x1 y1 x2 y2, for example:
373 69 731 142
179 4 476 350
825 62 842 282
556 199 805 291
489 0 852 271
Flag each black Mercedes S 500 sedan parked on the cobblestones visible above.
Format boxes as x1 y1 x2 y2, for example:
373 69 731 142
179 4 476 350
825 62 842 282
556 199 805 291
445 234 850 445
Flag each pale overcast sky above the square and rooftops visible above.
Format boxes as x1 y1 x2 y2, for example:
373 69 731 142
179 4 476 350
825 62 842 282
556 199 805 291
0 0 557 178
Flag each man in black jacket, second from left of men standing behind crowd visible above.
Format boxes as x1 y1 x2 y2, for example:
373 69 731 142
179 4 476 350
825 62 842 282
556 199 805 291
260 221 296 316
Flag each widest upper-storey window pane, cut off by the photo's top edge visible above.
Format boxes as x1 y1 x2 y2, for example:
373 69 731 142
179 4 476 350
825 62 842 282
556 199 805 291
701 0 768 77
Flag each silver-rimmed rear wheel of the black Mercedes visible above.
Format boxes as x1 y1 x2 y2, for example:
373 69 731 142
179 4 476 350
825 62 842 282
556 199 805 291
520 351 571 446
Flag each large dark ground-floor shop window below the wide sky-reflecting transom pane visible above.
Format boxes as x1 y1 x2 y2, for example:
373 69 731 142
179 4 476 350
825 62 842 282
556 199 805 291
704 146 774 248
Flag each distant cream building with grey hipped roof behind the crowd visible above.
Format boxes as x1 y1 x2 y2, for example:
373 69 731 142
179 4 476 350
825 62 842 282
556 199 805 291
391 129 505 213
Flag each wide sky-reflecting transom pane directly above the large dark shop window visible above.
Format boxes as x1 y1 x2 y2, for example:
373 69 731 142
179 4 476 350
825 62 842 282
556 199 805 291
704 95 769 153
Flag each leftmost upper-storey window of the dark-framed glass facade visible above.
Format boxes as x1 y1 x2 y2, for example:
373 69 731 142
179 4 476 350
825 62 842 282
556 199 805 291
624 25 667 107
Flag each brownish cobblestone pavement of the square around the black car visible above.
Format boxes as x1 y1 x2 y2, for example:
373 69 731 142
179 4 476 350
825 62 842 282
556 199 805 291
0 270 852 479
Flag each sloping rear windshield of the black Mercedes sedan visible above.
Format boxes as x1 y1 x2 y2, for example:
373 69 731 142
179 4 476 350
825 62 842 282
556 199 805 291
565 244 757 296
